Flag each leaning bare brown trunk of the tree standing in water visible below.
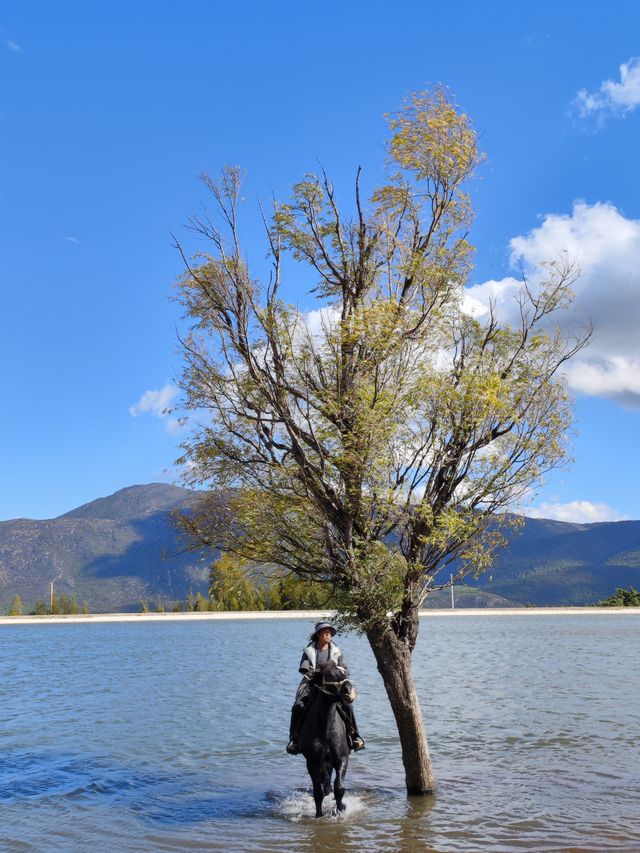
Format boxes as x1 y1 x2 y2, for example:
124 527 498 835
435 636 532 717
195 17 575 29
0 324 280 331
367 629 436 795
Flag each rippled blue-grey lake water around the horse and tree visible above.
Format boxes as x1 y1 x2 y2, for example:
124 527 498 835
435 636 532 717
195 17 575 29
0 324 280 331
0 615 640 853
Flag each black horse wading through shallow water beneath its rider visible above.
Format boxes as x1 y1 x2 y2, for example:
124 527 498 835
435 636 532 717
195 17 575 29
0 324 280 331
300 660 353 817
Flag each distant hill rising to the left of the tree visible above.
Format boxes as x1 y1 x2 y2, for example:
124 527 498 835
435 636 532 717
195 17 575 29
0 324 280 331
0 483 212 612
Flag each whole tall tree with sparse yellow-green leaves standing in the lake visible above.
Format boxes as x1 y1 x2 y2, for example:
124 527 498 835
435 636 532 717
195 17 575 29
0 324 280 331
178 88 590 794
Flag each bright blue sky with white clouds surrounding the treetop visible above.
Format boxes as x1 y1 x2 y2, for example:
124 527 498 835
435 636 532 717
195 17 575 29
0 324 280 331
0 0 640 521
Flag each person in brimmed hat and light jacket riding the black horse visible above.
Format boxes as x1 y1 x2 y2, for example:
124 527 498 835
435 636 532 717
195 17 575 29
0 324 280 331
286 622 365 755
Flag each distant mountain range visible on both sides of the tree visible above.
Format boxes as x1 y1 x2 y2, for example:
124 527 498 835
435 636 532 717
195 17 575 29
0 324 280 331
0 483 640 612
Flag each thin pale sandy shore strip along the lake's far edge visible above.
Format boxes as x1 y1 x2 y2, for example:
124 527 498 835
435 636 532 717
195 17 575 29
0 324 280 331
0 607 640 625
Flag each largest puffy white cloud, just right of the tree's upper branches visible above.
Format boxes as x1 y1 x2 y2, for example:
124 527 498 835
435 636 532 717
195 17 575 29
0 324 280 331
465 202 640 407
